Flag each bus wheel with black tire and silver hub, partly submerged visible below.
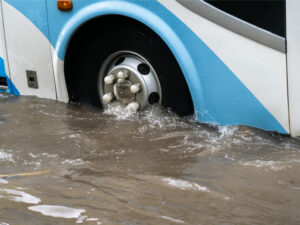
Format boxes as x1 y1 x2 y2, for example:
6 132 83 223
81 20 193 115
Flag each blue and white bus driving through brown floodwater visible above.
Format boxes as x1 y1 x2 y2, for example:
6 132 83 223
0 0 300 136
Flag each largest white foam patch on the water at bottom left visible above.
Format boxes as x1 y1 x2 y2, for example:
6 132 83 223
28 205 85 219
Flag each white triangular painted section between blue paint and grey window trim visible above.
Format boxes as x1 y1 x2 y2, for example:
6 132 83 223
158 0 289 131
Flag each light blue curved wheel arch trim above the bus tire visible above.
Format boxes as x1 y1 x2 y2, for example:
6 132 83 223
55 1 204 114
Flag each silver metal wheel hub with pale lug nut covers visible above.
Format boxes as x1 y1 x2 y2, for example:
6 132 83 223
98 51 162 112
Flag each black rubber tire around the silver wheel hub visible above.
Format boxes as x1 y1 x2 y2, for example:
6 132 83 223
69 18 193 115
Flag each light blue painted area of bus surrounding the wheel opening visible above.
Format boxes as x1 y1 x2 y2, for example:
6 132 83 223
3 0 288 134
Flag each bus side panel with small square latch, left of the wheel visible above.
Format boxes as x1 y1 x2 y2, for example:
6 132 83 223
2 0 56 99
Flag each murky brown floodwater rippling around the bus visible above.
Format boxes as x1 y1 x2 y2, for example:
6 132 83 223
0 94 300 225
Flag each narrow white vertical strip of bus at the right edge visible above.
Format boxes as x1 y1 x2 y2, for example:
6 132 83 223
286 0 300 136
